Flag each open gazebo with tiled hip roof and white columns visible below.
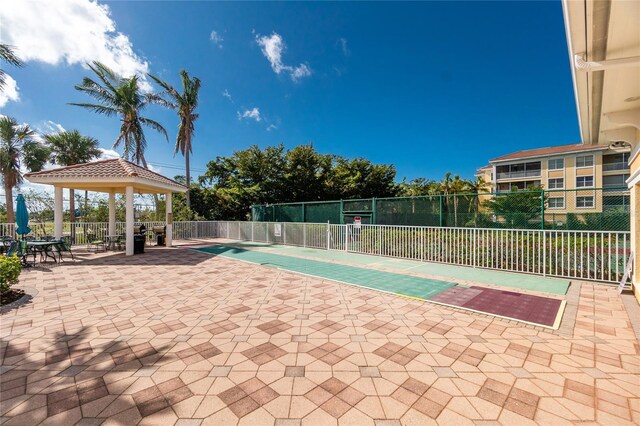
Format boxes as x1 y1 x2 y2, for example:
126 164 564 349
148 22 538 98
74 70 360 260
25 158 187 256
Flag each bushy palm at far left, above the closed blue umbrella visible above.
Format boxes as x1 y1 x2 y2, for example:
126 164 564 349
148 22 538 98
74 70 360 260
0 116 49 223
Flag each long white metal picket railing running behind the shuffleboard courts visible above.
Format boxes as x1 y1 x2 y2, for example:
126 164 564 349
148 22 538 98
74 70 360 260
0 221 631 282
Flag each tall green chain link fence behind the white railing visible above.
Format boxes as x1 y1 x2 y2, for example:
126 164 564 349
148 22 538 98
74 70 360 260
251 187 630 231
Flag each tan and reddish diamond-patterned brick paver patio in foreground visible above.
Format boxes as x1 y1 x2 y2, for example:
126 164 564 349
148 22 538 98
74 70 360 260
0 248 640 426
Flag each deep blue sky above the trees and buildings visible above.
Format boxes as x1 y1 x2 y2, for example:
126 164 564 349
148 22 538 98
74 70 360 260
0 0 579 179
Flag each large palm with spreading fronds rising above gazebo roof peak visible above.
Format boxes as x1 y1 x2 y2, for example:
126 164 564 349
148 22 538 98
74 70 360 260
71 61 169 168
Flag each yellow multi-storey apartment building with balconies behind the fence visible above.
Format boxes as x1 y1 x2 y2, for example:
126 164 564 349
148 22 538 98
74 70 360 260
476 144 630 214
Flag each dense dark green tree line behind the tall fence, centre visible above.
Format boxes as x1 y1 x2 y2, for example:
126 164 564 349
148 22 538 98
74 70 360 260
176 144 488 220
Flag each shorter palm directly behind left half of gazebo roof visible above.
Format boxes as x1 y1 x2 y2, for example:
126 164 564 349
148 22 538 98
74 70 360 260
44 130 101 238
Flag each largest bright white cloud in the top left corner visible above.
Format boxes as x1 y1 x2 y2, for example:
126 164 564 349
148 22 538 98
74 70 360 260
0 0 151 91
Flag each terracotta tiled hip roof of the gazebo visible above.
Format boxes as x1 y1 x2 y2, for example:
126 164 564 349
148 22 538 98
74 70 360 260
25 158 186 192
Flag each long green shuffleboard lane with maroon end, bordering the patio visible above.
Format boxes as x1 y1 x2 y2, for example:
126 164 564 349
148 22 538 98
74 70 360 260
194 245 565 329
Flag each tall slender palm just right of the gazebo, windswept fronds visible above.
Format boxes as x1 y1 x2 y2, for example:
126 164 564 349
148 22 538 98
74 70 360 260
149 70 200 207
